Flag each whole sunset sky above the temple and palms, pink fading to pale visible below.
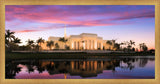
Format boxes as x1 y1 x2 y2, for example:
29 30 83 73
5 5 155 49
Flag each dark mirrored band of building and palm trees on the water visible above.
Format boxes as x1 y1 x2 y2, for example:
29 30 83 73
5 58 154 79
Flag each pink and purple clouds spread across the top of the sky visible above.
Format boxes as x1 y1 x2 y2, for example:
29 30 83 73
6 5 155 32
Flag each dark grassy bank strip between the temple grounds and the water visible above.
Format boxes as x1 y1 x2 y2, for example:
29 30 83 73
5 52 154 60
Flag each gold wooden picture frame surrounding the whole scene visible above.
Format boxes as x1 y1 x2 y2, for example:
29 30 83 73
0 0 160 84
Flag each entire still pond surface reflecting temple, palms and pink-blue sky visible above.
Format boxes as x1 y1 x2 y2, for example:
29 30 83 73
5 58 154 79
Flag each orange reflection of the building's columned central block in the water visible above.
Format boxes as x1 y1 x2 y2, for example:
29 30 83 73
70 61 103 77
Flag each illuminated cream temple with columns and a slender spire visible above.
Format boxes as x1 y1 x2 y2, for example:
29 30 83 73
41 24 114 50
